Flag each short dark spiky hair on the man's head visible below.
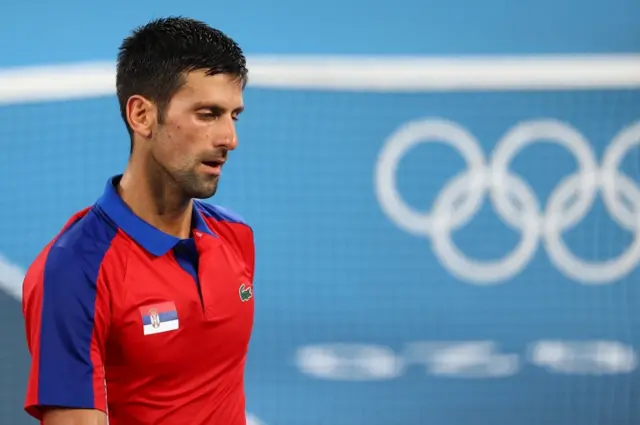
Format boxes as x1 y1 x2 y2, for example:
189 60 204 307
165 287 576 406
116 17 248 149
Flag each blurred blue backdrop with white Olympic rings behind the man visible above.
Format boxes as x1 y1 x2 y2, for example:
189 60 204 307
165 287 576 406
0 0 640 425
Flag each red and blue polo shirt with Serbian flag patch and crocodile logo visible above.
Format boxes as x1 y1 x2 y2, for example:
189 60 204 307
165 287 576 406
23 176 254 425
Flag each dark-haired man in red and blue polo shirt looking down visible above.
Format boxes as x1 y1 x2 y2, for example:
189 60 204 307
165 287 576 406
23 18 254 425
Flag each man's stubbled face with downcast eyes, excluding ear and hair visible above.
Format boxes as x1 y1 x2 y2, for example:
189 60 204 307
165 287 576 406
151 71 243 199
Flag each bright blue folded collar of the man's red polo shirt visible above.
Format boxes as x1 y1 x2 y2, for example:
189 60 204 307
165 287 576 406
96 175 215 257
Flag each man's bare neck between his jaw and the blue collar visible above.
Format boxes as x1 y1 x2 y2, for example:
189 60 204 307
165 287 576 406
117 164 193 239
